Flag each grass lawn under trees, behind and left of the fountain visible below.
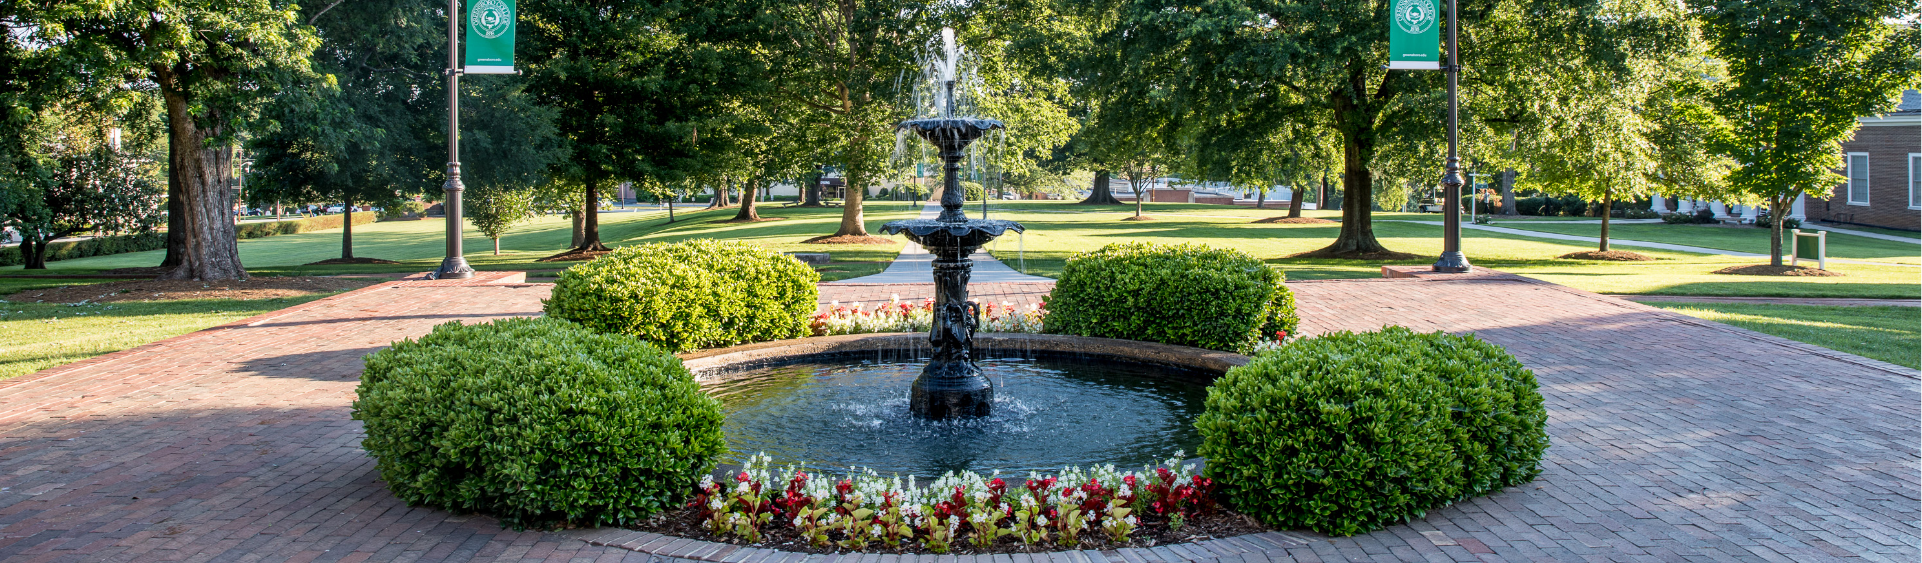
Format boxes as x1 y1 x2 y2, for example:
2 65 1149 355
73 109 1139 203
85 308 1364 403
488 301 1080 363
11 202 917 279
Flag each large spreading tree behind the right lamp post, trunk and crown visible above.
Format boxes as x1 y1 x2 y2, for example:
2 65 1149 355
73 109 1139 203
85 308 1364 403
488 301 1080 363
1097 0 1670 257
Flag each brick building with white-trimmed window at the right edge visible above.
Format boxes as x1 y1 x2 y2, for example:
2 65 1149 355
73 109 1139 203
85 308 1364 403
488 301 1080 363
1807 90 1922 231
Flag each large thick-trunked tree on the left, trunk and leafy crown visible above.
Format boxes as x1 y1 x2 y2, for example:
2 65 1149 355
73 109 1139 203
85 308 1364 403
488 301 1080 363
29 0 319 281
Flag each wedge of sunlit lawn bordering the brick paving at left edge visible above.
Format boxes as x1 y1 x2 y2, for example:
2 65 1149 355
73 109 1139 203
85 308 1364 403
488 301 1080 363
0 296 323 379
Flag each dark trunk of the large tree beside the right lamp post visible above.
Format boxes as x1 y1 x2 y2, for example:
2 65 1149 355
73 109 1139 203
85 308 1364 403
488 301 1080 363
1317 92 1390 257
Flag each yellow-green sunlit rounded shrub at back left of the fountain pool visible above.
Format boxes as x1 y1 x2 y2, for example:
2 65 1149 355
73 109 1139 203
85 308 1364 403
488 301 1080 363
544 238 821 352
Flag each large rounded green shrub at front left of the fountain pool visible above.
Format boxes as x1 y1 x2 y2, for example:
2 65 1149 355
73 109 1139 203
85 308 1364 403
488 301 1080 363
354 319 727 528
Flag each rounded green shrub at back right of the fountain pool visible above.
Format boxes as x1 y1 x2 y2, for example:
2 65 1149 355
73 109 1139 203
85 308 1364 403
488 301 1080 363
1046 242 1299 352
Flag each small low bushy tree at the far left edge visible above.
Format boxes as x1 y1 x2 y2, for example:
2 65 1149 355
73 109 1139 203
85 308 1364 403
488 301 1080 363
0 108 167 269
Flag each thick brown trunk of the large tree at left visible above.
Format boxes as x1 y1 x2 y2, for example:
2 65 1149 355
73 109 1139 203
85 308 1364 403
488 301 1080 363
158 77 246 281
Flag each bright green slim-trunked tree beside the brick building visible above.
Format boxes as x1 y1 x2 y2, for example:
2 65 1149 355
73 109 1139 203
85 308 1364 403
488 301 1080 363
1689 0 1922 267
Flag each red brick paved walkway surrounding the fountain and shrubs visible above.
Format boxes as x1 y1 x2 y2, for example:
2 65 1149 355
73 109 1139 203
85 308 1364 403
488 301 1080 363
0 279 1922 563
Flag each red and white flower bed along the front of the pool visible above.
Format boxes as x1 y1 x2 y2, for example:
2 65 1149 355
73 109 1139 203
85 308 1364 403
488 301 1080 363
636 453 1265 553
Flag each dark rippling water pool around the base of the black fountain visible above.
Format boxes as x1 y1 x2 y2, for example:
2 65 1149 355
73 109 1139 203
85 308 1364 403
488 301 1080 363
682 332 1247 478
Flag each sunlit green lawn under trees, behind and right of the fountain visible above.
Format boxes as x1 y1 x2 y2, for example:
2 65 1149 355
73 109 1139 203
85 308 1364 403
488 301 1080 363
992 202 1922 298
